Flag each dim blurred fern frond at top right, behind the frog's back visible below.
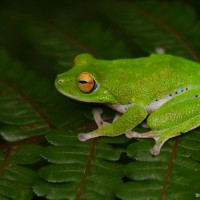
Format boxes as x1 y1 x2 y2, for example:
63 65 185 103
100 0 200 61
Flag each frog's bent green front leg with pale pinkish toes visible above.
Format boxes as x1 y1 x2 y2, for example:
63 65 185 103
78 104 147 141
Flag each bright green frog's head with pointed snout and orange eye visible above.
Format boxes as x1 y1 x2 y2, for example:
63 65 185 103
55 54 117 103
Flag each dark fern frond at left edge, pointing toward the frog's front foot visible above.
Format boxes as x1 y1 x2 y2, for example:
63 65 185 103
0 52 53 138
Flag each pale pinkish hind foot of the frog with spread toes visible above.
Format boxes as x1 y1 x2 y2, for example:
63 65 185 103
125 131 171 156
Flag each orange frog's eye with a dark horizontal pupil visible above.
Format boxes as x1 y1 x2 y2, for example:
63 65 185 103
77 72 97 93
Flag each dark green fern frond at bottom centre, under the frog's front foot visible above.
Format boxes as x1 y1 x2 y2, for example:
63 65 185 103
34 130 122 199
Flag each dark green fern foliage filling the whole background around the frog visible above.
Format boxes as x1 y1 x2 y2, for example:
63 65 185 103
0 0 200 200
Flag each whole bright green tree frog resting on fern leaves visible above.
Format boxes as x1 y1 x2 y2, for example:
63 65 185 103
55 53 200 155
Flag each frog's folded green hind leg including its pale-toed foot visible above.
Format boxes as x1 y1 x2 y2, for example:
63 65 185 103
125 92 200 155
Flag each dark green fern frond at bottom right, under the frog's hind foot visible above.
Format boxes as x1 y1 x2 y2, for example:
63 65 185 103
118 131 200 200
